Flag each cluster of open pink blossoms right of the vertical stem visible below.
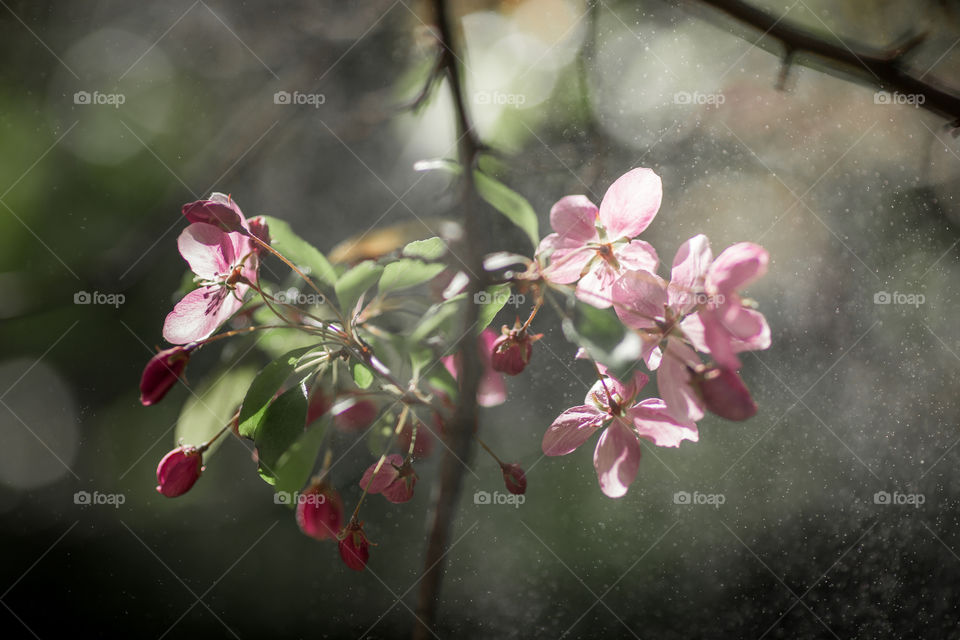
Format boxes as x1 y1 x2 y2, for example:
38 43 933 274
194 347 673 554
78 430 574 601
539 169 770 498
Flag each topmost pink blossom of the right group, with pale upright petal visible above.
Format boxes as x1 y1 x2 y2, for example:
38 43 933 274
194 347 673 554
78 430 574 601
537 168 663 309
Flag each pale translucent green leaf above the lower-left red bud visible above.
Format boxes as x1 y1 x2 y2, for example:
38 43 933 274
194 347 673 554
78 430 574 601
174 367 256 459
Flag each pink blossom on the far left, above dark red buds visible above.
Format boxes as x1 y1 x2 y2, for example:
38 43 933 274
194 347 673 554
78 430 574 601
163 201 259 344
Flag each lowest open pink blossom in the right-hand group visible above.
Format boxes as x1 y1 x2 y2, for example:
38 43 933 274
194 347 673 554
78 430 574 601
542 366 700 498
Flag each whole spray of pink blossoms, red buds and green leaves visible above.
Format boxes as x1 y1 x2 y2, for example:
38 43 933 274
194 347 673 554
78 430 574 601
140 169 770 570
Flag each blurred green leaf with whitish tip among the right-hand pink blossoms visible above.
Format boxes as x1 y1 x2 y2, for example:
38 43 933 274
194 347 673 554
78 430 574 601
562 300 643 377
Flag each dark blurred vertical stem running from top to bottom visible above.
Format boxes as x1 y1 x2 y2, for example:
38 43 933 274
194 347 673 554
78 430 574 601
413 0 487 640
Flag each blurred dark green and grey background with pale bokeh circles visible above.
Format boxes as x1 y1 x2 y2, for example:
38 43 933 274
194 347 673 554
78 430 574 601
0 0 960 638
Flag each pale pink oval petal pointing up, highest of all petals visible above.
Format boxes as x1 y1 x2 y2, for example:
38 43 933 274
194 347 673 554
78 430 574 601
600 169 663 241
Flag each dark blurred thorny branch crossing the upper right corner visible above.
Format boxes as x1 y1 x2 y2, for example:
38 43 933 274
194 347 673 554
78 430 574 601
697 0 960 127
